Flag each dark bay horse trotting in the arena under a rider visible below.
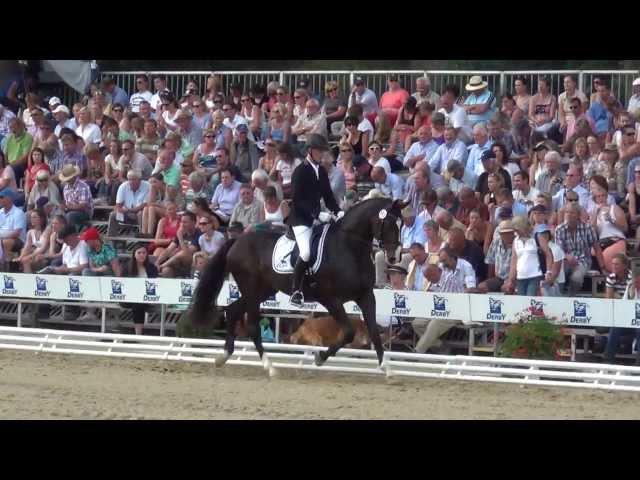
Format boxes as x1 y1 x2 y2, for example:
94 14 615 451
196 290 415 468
191 198 405 366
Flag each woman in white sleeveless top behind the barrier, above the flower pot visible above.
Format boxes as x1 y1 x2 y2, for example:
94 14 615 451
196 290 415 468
505 217 553 297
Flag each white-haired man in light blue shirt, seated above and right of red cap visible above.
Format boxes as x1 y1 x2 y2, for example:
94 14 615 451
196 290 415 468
107 170 151 236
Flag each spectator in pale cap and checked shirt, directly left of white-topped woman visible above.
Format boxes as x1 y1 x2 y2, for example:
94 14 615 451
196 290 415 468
474 220 515 294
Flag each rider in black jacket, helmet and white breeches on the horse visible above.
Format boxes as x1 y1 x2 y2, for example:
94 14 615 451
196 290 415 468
288 134 344 307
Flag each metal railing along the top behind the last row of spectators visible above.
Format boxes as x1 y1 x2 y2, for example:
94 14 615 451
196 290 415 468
57 70 640 105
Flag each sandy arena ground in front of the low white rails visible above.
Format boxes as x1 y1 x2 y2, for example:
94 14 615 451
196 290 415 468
0 350 640 419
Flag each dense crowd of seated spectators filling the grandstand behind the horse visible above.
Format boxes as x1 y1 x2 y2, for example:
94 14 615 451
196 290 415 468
0 71 640 351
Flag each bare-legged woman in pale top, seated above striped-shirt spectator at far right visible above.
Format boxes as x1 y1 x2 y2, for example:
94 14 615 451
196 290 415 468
587 181 628 272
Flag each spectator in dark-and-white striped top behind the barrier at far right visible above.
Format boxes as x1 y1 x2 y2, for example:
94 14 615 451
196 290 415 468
604 253 640 363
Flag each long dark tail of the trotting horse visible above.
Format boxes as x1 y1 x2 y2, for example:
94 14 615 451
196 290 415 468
191 238 236 325
